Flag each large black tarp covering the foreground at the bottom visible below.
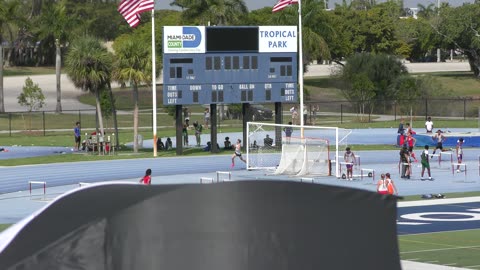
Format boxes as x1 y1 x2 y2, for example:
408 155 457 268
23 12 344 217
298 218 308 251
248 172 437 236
0 181 401 270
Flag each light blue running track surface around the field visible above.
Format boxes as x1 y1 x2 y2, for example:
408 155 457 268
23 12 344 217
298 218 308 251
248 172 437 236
0 128 480 230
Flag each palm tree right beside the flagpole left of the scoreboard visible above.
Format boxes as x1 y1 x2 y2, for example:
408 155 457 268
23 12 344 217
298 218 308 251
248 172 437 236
113 38 151 153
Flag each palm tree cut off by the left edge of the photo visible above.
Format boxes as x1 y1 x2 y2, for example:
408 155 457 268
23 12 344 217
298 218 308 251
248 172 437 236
0 0 23 112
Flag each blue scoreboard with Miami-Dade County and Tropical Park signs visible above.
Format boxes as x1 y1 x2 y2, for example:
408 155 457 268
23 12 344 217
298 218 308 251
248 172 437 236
163 26 298 105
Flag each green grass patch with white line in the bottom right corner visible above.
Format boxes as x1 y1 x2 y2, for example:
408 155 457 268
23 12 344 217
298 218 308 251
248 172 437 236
398 229 480 269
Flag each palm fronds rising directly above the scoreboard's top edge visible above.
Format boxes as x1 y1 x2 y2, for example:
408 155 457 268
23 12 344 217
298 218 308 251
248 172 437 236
171 0 248 25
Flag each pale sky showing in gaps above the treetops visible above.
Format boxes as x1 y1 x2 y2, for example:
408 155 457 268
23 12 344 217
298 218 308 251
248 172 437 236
155 0 474 10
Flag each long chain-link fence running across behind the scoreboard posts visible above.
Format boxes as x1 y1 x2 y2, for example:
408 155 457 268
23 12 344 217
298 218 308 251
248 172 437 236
0 98 480 137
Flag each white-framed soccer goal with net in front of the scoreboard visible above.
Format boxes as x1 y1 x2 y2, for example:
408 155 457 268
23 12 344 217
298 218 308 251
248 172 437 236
246 122 351 177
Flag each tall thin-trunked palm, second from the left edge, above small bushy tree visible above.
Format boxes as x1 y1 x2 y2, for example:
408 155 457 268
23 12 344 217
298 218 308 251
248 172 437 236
38 0 74 113
